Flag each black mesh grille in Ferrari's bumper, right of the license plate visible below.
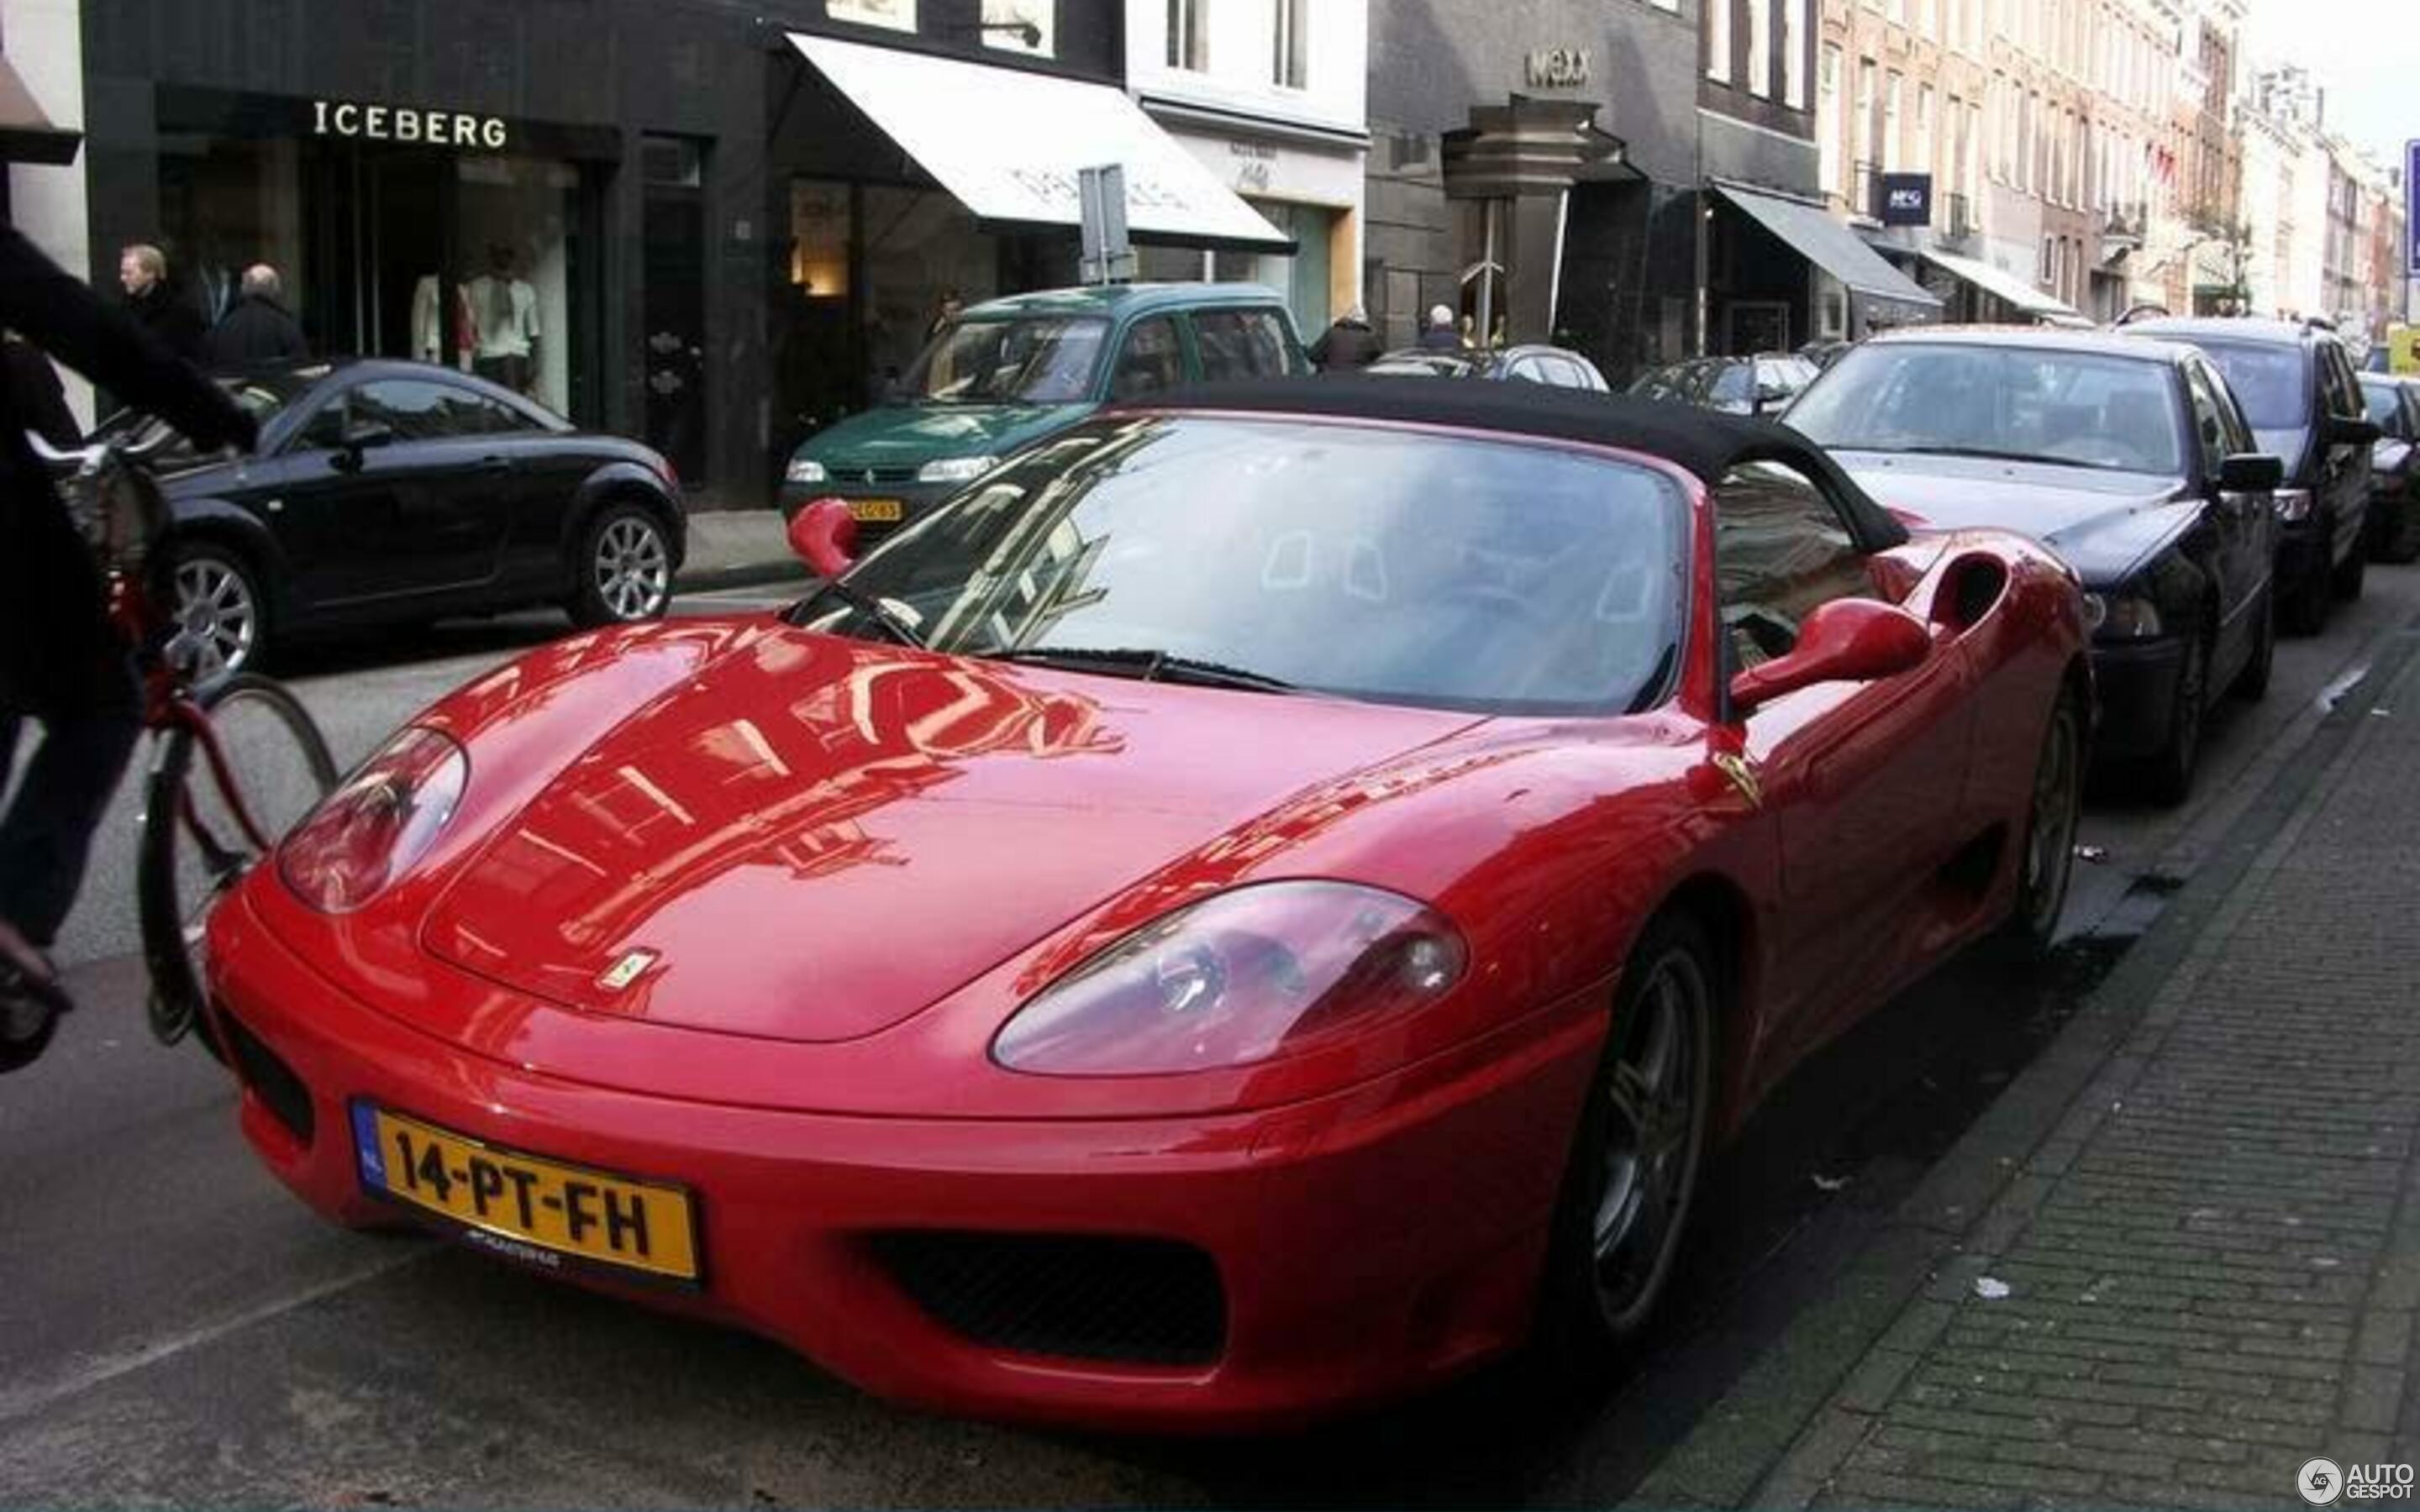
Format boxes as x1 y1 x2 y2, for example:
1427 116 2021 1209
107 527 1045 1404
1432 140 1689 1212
874 1234 1227 1364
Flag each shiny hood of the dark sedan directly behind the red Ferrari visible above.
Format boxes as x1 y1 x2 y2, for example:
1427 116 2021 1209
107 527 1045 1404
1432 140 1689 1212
1834 453 2202 583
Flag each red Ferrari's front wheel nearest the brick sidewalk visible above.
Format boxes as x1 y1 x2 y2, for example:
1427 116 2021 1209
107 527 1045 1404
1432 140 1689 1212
1534 915 1728 1379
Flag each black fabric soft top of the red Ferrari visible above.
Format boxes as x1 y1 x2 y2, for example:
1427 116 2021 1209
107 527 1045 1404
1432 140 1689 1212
1118 375 1907 552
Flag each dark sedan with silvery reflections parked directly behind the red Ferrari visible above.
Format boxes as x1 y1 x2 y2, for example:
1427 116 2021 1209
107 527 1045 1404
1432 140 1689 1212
1784 327 2282 801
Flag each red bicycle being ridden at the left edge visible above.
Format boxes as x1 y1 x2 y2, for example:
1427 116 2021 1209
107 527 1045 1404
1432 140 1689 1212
17 426 336 1062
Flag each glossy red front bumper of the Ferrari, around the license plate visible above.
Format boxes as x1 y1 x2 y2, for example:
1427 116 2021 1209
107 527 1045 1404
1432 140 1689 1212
211 895 1602 1432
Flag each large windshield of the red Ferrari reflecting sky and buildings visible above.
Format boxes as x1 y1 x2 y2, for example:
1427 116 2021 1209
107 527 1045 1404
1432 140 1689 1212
801 416 1686 714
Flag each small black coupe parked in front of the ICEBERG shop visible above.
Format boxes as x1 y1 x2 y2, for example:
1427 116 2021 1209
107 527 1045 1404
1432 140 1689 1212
99 358 687 673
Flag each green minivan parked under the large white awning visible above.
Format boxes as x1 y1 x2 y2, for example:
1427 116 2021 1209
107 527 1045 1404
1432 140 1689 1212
779 283 1312 542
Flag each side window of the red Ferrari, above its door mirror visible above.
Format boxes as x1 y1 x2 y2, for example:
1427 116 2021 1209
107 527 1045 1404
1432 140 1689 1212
1713 462 1873 668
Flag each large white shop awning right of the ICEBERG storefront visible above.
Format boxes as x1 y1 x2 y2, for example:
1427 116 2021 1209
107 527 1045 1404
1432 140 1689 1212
789 31 1295 252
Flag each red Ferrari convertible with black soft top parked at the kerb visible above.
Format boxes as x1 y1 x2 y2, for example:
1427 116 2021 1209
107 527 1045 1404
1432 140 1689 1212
208 380 2091 1427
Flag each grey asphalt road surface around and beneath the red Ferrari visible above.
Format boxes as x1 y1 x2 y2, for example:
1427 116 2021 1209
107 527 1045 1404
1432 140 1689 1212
0 569 2420 1507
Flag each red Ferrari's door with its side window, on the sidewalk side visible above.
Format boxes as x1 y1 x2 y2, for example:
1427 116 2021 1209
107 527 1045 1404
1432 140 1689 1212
1713 462 1972 1038
